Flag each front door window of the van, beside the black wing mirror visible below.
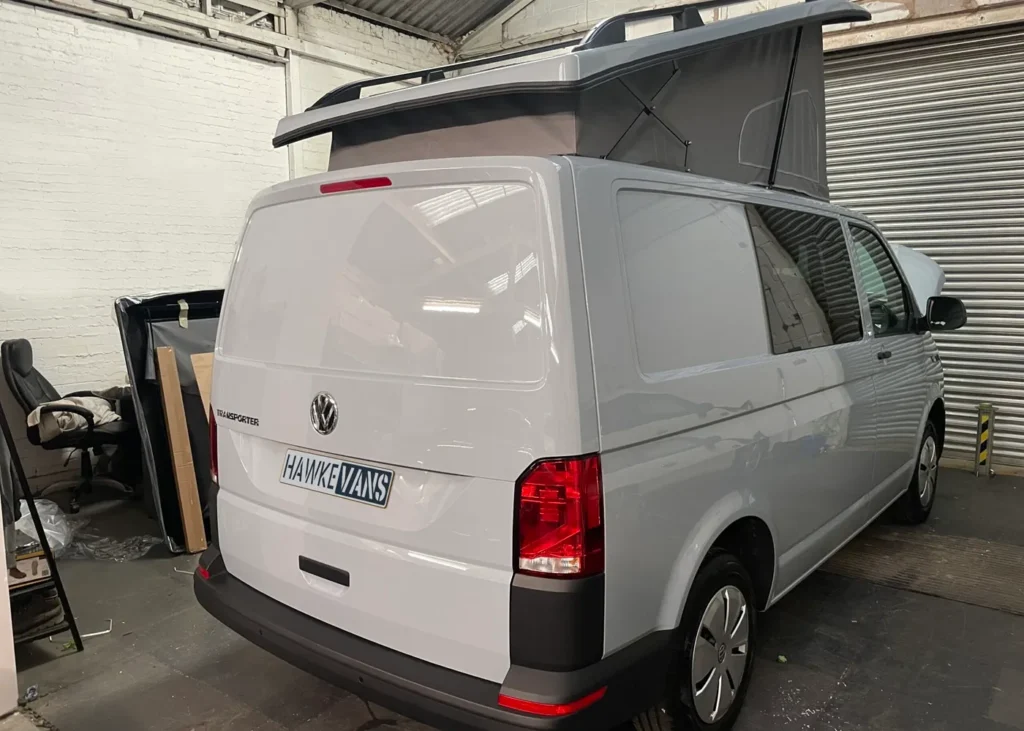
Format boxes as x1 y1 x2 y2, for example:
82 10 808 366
850 223 910 337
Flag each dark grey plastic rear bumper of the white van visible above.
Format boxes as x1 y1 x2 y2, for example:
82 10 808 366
195 548 671 731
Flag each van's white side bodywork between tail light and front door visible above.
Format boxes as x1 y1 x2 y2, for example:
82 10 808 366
573 160 874 653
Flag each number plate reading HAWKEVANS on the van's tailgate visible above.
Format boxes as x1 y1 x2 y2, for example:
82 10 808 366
281 449 394 508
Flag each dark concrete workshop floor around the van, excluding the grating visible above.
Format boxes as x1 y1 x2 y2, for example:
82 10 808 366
18 471 1024 731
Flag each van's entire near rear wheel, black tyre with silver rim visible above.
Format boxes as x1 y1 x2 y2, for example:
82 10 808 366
633 552 757 731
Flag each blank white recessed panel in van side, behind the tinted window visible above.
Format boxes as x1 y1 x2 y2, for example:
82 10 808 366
617 190 768 375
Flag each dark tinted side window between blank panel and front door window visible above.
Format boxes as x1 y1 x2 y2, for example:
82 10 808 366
746 206 863 353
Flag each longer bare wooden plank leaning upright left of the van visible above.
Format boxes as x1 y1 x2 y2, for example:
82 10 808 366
157 347 206 553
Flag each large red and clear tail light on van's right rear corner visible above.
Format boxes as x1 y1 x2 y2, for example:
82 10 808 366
517 455 604 578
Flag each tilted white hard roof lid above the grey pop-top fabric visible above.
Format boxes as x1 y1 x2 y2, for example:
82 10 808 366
273 0 871 146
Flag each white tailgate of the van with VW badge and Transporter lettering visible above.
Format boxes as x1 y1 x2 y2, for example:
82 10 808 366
213 159 597 682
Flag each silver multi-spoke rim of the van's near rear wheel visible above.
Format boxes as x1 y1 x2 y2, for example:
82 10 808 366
690 586 751 724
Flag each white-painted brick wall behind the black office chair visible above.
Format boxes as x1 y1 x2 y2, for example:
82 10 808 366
0 2 288 483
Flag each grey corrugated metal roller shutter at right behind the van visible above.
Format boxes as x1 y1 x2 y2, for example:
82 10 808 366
825 27 1024 465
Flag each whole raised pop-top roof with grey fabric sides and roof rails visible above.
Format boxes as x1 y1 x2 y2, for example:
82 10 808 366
273 0 870 198
